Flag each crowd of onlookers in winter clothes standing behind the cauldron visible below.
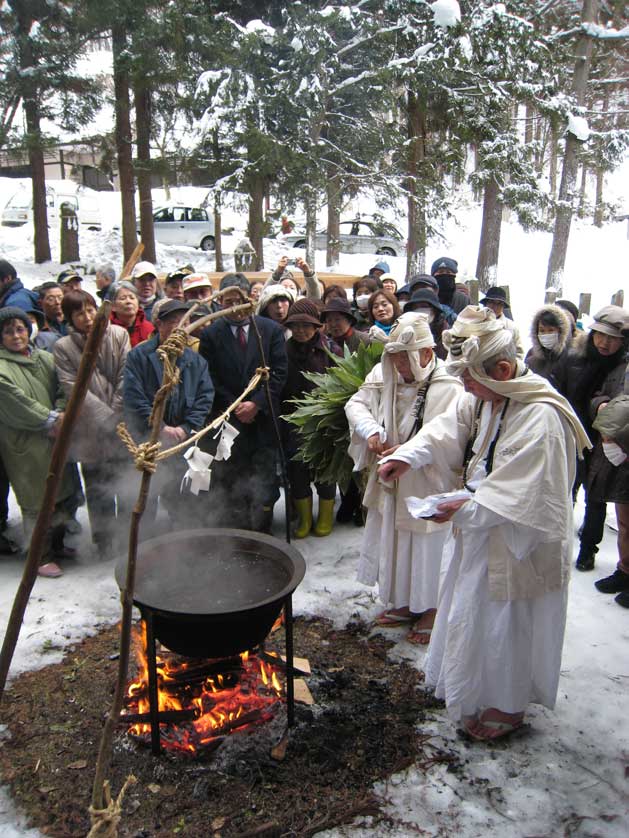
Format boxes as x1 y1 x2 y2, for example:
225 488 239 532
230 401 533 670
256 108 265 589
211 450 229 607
0 257 629 606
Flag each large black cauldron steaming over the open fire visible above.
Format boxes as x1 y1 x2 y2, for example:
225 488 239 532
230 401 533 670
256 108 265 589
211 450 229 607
116 529 306 658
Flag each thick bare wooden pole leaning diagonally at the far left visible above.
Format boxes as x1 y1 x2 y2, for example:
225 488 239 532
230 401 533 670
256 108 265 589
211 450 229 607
0 302 111 701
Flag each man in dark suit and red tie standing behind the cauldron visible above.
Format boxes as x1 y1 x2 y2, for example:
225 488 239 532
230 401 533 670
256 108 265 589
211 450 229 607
199 274 287 532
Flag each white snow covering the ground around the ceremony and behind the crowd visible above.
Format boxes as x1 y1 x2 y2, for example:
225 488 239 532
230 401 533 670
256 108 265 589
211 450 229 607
0 180 629 838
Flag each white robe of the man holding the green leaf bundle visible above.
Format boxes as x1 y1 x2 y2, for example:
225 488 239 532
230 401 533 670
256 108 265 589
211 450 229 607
345 361 461 614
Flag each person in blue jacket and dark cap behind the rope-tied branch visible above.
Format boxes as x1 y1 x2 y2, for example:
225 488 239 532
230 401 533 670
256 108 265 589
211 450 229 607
123 300 214 529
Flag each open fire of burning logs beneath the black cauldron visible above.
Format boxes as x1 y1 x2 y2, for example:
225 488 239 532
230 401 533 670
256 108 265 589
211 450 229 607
121 623 284 754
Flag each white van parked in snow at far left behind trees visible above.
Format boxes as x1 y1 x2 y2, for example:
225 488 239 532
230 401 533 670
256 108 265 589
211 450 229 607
2 180 102 230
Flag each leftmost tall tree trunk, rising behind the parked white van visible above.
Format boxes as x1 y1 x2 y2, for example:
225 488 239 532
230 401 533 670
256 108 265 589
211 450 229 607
11 0 50 264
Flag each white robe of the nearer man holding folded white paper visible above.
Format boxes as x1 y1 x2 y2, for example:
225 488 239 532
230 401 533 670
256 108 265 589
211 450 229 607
394 394 575 719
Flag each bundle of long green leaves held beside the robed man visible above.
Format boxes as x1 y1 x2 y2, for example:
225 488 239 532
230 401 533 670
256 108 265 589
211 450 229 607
283 343 384 492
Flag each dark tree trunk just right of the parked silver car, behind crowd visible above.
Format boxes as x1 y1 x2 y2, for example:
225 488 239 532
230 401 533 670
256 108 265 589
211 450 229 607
406 90 426 281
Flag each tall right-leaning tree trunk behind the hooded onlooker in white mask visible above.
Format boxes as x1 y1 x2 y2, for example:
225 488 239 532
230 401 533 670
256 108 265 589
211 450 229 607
546 0 598 294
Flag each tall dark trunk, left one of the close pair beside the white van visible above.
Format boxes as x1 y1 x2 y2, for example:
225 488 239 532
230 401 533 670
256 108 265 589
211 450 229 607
111 24 138 263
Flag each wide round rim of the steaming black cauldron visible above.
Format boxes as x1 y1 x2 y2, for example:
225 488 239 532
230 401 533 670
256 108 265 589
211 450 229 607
114 527 306 620
